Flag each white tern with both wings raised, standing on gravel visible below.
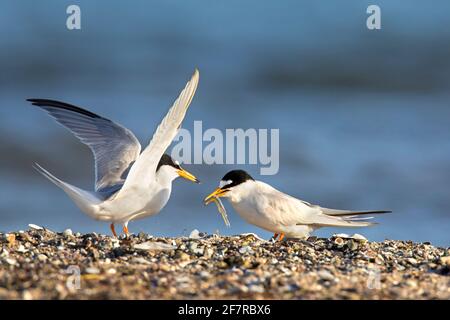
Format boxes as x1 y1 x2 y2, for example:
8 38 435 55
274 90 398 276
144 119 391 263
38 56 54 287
28 70 199 236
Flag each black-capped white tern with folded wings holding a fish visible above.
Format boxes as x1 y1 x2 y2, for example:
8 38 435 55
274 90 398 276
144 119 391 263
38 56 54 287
204 170 391 240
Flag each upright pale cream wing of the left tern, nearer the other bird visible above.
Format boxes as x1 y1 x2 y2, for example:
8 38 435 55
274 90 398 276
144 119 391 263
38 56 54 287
120 69 199 192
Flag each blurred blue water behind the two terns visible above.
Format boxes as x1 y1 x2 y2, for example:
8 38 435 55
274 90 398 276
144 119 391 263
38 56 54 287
0 0 450 246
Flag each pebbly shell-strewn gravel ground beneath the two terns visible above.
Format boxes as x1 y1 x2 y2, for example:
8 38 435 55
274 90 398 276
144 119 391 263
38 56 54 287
0 225 450 299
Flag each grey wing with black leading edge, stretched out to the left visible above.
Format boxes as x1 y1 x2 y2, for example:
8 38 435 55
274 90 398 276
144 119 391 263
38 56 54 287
27 99 141 191
